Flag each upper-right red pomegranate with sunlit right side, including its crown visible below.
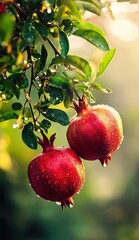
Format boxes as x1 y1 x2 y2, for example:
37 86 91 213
67 97 123 166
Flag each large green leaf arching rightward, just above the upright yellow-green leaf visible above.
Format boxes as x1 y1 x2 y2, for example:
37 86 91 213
73 29 109 51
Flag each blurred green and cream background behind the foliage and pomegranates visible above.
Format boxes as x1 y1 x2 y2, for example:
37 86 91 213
0 2 139 240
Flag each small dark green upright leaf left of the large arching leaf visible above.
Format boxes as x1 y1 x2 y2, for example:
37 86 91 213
59 31 69 57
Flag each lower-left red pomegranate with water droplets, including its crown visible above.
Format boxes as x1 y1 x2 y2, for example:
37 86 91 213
28 134 85 209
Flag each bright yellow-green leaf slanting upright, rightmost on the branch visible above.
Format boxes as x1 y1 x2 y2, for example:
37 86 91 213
97 49 116 77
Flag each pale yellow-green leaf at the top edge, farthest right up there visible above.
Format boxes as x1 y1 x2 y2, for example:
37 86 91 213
76 1 101 15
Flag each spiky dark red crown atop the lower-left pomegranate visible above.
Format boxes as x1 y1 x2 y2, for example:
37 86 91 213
38 132 56 152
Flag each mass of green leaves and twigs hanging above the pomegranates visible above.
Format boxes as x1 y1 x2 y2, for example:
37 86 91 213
0 0 115 149
